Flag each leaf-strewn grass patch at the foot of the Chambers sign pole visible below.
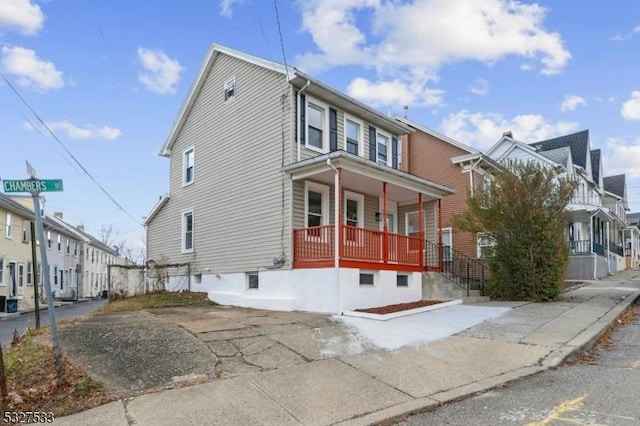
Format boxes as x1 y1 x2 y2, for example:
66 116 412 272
3 327 115 417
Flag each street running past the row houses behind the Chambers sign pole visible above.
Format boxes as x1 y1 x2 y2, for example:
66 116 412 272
0 299 107 350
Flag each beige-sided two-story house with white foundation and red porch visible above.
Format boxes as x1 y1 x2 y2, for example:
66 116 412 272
145 45 454 312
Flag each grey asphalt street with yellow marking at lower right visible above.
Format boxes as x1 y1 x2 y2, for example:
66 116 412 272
398 305 640 426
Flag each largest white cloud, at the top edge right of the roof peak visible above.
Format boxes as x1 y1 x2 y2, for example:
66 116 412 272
296 0 571 108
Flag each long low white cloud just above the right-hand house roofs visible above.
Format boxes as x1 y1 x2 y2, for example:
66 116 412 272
441 110 578 151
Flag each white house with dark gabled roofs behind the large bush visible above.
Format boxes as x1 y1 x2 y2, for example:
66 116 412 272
487 130 615 279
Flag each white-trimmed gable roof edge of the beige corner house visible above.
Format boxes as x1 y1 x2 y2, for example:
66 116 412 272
160 43 412 157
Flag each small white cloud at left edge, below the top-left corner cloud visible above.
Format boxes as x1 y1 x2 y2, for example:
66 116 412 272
2 46 64 91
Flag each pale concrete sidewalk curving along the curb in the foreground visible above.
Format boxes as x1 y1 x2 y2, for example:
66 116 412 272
56 270 640 426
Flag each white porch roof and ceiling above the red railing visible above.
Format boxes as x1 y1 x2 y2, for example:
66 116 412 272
284 151 455 203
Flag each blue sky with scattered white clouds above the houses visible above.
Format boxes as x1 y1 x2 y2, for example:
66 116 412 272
0 0 640 253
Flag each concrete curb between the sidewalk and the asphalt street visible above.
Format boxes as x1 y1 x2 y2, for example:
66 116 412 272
337 290 640 426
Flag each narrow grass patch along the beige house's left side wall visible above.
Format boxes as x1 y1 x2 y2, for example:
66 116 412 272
100 291 215 312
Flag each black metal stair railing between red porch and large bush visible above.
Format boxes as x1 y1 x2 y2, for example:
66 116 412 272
425 241 489 296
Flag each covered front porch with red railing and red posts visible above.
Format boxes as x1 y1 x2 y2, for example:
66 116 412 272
285 151 454 272
